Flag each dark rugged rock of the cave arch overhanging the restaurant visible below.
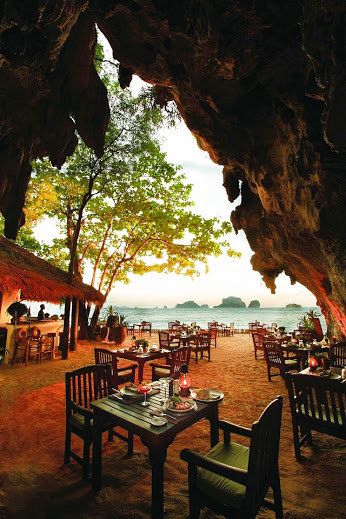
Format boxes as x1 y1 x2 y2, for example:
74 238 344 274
0 0 346 334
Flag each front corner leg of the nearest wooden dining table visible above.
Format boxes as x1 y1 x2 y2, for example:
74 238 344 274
148 446 167 519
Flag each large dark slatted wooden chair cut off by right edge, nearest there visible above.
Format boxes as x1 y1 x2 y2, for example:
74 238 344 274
285 373 346 460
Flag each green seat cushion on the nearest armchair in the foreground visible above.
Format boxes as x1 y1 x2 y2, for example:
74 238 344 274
197 442 249 509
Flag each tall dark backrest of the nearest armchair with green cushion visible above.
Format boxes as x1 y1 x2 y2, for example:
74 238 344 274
245 396 283 517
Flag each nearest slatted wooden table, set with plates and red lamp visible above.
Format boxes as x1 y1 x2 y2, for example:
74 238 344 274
91 390 221 519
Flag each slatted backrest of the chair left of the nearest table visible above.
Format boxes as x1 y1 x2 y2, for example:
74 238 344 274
65 364 112 415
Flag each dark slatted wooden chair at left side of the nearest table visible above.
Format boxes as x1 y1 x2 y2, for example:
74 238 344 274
64 364 133 480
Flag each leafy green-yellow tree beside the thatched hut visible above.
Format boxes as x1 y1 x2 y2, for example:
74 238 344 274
26 66 238 350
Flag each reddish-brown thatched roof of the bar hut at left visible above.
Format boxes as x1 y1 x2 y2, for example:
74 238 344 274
0 236 104 303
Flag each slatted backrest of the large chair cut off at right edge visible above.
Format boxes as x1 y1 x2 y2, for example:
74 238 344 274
285 373 346 432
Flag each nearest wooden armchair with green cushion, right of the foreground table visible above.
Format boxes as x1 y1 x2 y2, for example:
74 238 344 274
180 396 283 519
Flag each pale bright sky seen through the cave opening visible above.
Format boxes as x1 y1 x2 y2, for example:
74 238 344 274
37 35 316 307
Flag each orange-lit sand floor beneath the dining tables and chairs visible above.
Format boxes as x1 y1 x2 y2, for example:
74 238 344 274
0 335 346 519
